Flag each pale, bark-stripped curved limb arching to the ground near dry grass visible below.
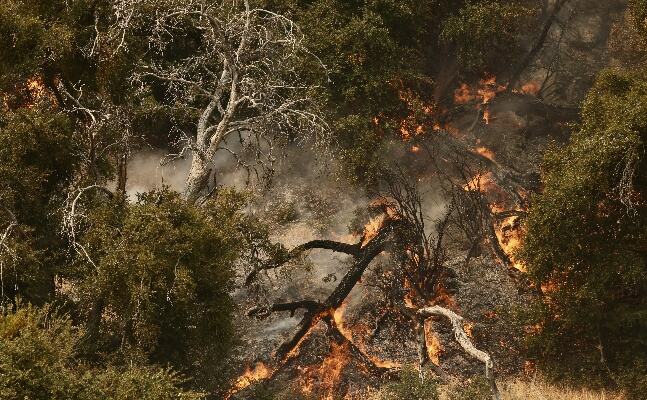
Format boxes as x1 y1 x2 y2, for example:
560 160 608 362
417 306 501 400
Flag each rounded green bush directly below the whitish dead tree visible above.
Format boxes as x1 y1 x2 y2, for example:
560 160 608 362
68 190 244 389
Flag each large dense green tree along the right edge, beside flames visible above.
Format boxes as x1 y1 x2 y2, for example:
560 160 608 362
521 67 647 396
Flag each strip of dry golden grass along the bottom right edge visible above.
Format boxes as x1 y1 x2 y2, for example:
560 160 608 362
500 380 624 400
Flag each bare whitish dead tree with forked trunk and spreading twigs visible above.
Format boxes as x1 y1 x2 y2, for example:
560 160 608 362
127 0 328 202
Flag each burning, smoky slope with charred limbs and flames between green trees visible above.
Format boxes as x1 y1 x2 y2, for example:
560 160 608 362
230 67 576 399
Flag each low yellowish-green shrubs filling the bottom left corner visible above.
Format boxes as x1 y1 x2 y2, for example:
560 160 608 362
0 306 203 400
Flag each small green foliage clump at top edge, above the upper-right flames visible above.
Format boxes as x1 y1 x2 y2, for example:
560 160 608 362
440 0 531 72
